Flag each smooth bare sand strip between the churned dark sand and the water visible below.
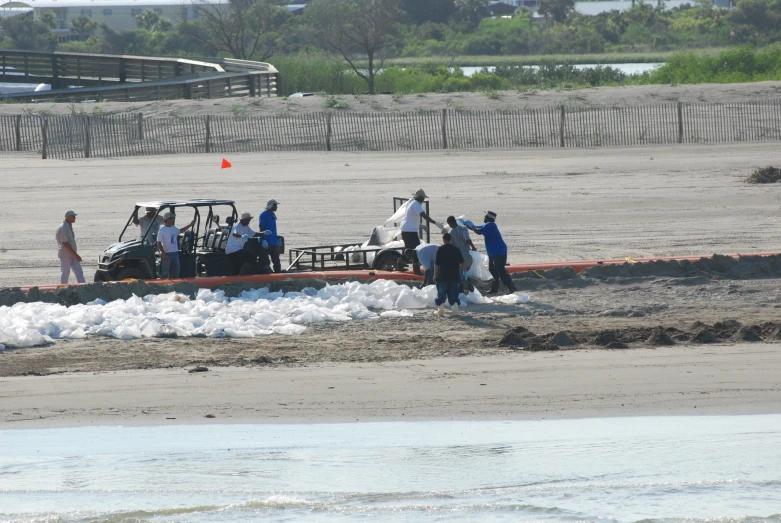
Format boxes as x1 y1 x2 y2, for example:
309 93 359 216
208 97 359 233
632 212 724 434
0 344 781 429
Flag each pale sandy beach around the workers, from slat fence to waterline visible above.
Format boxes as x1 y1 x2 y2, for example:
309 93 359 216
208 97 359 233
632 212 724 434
0 140 781 428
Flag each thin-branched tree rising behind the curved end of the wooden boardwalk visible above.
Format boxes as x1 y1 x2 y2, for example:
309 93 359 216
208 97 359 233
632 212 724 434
187 0 291 61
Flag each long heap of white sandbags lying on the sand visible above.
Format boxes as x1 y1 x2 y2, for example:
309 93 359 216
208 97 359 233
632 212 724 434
0 280 528 347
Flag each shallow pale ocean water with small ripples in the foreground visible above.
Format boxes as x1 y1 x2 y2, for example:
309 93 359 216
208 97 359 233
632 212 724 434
0 415 781 523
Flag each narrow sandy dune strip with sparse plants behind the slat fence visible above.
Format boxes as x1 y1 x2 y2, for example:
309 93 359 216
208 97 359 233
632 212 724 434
0 81 781 118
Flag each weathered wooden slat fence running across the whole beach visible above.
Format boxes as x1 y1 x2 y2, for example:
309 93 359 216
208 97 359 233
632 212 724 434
0 100 781 159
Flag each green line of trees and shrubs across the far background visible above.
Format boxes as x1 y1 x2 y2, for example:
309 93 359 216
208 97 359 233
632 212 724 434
0 0 781 92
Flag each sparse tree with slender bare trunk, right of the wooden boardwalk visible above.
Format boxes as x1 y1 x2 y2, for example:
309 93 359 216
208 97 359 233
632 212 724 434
304 0 402 93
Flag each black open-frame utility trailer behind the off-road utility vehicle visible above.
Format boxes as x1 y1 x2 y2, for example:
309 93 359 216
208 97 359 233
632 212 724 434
286 196 431 272
